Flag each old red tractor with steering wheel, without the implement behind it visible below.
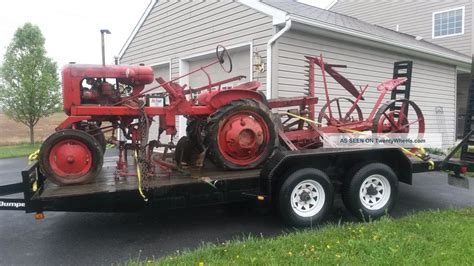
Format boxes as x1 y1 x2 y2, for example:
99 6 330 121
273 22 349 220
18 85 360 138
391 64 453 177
39 46 317 185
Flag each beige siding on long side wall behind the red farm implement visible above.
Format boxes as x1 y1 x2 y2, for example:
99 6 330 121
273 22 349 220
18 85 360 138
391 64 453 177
275 31 456 147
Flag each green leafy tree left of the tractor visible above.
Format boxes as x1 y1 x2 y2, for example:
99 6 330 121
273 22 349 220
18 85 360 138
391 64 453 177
0 23 61 143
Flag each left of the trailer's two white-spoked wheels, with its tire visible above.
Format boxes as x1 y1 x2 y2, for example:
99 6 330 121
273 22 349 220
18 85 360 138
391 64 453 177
278 168 334 227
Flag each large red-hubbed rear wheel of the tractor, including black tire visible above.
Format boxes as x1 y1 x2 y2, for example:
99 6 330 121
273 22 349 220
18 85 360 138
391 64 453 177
205 99 277 170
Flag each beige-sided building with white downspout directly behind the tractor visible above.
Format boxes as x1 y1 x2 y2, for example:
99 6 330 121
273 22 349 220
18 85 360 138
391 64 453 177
120 0 470 147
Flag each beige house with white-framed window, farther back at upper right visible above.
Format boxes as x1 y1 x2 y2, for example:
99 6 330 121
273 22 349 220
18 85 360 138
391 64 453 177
330 0 474 137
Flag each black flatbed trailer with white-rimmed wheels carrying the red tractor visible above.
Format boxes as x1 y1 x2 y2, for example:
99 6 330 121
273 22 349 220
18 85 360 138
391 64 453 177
0 57 474 226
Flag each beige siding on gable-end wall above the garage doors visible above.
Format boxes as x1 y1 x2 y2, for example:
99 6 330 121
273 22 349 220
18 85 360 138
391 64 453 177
121 1 273 87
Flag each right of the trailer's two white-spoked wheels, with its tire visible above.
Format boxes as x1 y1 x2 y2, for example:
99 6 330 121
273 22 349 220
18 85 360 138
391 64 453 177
342 163 398 221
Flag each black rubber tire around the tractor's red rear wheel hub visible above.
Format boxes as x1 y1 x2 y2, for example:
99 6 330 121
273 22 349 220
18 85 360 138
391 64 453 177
204 99 277 170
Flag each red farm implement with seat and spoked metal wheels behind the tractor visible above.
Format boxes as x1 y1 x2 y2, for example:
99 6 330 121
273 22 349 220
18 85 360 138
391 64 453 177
283 55 425 149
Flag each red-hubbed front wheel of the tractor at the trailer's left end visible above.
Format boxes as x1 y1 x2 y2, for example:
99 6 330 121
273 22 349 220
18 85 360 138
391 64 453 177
39 129 104 185
